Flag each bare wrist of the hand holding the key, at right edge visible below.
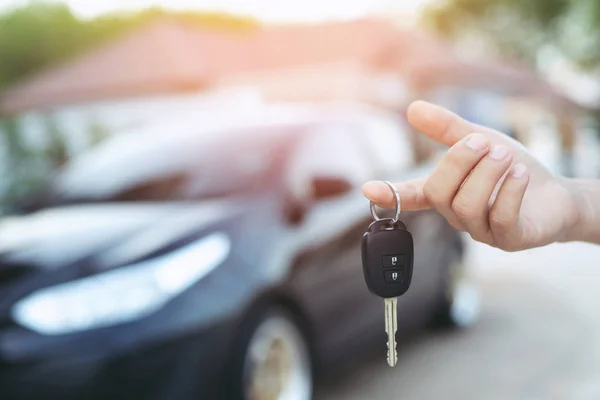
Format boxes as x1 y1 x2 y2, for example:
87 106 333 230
561 178 600 243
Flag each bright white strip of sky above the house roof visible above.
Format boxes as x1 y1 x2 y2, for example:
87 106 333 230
0 0 430 23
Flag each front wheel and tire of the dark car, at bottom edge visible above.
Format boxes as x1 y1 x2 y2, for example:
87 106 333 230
224 307 313 400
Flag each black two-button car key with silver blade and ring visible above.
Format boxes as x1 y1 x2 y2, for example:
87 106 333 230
362 182 414 367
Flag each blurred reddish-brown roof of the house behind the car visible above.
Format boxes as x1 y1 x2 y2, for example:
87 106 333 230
0 19 572 114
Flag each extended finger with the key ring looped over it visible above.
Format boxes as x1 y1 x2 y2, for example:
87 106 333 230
362 178 431 211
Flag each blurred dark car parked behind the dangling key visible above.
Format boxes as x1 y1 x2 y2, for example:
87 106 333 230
0 105 474 399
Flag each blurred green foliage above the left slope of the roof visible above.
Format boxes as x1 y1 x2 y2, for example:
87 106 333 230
0 2 258 91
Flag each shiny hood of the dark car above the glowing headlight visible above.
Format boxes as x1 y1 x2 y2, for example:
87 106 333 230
0 201 239 269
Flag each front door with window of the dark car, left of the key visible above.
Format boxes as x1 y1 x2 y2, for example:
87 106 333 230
280 123 383 357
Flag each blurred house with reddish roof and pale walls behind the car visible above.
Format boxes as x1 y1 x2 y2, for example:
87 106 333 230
0 19 580 159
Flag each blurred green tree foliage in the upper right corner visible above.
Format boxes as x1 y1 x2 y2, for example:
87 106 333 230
424 0 600 68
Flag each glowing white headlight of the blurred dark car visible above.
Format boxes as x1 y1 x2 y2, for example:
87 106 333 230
12 233 231 335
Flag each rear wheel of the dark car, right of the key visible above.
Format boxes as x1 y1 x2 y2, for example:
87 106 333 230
433 258 481 328
